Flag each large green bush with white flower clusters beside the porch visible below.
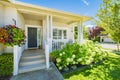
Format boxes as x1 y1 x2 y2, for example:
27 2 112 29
51 41 107 70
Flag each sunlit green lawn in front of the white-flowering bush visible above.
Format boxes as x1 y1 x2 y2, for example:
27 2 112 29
63 53 120 80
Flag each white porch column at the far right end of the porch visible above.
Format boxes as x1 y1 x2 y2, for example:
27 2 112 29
78 21 83 44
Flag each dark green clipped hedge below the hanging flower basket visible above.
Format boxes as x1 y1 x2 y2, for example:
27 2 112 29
0 54 13 77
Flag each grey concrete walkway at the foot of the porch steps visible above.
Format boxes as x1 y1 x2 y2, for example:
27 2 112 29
10 63 64 80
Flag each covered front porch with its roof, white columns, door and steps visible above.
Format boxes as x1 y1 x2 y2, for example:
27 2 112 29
10 0 89 75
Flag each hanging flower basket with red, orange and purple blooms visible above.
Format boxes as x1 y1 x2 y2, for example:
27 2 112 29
0 25 25 46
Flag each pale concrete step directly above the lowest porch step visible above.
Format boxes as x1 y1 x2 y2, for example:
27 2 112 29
19 57 45 66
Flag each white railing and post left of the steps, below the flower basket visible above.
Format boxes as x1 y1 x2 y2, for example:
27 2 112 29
13 45 25 75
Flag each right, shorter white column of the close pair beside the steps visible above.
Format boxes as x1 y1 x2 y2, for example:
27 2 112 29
49 16 53 52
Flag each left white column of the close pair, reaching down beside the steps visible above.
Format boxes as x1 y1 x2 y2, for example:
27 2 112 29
45 15 50 68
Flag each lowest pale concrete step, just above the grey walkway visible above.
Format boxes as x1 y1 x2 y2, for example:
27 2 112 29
18 63 46 73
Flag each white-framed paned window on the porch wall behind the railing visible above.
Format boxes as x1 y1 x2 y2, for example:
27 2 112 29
53 28 67 39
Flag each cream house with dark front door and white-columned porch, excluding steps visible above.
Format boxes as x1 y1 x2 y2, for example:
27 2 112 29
0 0 91 75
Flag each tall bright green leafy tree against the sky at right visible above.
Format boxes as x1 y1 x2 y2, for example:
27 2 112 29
97 0 120 51
